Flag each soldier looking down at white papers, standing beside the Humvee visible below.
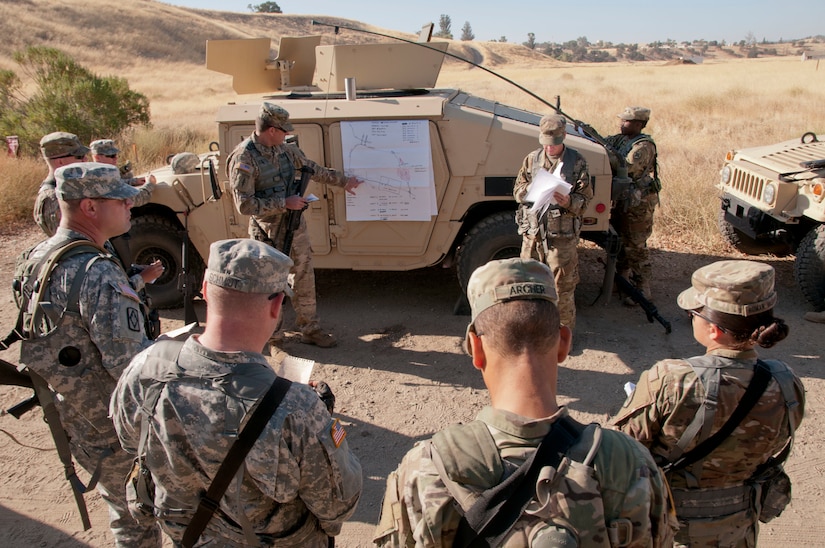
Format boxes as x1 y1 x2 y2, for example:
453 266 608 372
513 114 593 330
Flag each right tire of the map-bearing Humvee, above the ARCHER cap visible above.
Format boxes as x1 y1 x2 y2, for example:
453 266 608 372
456 211 521 293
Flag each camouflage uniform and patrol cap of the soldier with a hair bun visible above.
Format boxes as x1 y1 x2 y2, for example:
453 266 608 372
611 261 805 547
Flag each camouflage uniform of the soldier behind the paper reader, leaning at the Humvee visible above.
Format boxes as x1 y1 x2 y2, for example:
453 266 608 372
605 133 661 298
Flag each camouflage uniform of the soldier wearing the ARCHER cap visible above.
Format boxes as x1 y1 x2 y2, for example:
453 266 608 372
375 407 672 548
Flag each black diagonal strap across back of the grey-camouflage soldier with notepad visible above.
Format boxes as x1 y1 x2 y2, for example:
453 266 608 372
181 377 292 548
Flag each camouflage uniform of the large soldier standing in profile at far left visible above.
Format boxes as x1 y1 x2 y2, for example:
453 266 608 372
20 228 161 547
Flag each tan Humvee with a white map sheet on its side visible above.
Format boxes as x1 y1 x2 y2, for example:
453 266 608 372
131 36 613 307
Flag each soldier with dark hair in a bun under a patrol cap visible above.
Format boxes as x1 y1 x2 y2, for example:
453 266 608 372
612 261 805 547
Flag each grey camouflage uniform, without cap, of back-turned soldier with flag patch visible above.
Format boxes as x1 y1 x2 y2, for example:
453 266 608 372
111 337 362 548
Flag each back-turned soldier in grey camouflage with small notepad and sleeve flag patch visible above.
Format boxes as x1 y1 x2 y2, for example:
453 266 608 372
111 239 362 548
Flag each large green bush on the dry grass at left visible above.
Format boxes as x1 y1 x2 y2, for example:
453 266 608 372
0 46 150 157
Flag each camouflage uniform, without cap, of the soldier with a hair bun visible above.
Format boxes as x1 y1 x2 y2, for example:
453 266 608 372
612 349 805 547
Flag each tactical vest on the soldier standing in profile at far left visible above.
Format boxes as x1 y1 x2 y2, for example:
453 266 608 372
15 240 120 448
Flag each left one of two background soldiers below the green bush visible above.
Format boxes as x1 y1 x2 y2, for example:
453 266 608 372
34 131 89 236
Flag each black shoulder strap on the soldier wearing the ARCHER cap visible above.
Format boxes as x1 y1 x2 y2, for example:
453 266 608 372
453 417 584 548
